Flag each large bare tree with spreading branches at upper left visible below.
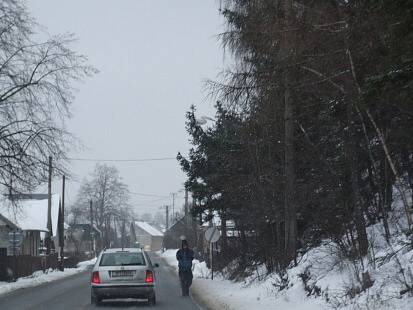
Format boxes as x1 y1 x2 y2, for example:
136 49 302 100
0 0 96 191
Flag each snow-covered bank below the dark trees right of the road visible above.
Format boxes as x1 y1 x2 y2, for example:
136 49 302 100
158 206 413 310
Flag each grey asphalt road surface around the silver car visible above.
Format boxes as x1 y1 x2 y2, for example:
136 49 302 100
0 256 199 310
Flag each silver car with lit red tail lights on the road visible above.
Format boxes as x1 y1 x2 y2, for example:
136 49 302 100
90 248 158 305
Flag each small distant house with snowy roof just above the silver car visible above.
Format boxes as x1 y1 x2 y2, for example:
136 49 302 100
131 221 163 251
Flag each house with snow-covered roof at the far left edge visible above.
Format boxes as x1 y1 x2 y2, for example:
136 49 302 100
0 194 60 256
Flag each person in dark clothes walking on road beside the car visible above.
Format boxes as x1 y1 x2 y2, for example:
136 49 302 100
176 240 194 296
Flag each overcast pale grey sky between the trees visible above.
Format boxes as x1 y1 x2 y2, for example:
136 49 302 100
27 0 223 214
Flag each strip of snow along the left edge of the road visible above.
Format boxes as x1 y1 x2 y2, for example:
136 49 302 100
0 258 96 295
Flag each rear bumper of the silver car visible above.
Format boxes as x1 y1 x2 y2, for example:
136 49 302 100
91 285 155 299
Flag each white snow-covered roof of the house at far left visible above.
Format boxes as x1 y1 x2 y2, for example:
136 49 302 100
0 194 60 235
